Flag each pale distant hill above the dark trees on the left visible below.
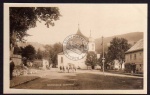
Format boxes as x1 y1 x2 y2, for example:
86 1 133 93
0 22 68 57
18 42 45 50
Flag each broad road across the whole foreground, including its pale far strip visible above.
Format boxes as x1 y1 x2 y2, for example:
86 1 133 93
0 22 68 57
15 69 143 90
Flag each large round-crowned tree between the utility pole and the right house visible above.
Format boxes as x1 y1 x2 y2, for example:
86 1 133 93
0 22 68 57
107 37 131 68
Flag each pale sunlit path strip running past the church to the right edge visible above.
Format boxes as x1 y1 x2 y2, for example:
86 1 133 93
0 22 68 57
25 68 143 79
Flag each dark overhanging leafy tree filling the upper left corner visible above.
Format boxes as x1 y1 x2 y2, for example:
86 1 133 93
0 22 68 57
9 7 61 56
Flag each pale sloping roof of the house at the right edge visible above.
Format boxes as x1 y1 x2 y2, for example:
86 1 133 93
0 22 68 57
126 39 143 53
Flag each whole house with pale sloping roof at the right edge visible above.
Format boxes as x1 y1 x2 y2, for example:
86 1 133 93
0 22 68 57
125 39 143 73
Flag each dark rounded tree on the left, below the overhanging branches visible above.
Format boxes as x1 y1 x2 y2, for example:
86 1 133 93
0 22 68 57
22 45 36 60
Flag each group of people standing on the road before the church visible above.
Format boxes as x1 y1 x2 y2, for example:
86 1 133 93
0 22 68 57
60 65 77 73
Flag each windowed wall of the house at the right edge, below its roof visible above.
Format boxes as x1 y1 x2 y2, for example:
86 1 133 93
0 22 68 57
125 50 143 72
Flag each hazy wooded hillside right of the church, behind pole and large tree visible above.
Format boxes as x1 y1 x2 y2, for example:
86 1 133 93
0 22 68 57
95 32 143 53
